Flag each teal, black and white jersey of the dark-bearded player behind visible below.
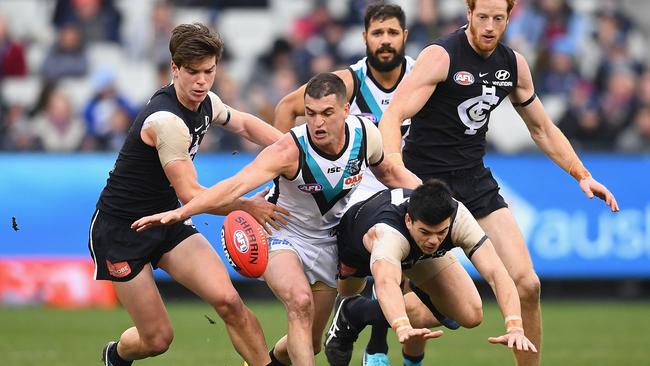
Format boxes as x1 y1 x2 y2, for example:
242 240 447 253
349 56 415 205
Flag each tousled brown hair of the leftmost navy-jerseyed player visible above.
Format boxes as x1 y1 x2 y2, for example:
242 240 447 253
169 23 223 67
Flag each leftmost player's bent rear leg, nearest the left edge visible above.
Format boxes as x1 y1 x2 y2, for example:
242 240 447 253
113 265 174 361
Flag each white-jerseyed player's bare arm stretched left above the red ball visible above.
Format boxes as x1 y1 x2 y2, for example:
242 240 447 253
131 135 298 231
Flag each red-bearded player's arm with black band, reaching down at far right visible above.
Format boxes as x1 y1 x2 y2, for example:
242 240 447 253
511 53 619 212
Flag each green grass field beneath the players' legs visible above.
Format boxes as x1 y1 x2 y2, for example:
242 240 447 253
0 301 650 366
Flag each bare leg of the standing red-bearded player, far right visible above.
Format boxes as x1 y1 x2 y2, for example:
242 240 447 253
478 208 542 366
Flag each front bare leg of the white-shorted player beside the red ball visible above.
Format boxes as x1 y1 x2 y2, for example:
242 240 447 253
264 250 316 366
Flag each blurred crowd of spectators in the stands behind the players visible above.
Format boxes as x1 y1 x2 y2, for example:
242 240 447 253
0 0 650 152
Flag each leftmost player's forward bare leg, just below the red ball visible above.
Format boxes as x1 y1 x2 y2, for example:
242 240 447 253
159 234 271 366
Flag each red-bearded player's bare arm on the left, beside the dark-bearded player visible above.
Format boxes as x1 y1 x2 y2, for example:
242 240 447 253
379 45 449 156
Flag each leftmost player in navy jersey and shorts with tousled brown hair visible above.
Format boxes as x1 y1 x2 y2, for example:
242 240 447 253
88 23 286 366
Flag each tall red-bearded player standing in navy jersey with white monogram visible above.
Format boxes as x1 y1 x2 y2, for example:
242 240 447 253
379 0 618 365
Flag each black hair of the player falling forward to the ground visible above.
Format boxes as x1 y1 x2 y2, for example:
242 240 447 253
407 179 457 225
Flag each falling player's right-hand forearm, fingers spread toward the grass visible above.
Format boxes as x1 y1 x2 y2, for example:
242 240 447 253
471 239 537 352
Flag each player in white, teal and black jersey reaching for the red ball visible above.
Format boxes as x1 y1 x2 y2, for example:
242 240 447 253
132 73 421 365
